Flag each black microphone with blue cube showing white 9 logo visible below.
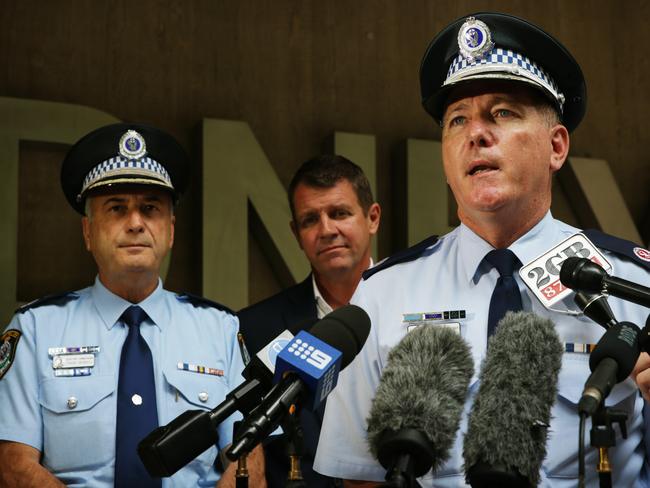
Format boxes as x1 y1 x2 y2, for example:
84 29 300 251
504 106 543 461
226 305 370 461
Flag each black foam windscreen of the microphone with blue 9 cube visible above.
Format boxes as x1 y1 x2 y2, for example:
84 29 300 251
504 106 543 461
309 305 370 369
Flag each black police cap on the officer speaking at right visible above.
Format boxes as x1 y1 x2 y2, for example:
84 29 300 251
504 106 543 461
420 12 587 131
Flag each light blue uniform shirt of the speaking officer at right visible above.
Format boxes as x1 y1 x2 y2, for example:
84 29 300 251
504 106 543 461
314 212 650 488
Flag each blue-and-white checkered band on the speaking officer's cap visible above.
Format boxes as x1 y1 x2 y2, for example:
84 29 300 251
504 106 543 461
443 47 564 111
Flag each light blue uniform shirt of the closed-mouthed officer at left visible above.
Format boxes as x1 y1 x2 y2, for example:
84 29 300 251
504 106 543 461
0 279 243 487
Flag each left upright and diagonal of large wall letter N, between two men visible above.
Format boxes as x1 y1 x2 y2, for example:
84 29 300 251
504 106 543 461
203 119 309 309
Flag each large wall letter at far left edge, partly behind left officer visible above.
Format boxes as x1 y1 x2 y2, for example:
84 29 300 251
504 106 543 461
0 97 118 324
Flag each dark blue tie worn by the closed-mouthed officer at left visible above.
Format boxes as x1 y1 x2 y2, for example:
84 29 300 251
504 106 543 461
115 305 161 488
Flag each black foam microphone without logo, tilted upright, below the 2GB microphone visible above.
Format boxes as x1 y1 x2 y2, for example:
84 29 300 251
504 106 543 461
578 322 641 415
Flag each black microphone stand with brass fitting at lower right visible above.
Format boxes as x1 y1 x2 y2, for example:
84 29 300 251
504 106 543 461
590 402 627 488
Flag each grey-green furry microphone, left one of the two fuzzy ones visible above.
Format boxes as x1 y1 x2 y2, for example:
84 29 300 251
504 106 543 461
368 325 474 487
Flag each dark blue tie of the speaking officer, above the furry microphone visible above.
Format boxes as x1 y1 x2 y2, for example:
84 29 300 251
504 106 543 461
485 249 522 337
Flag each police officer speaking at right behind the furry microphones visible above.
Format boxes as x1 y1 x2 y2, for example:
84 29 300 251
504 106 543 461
314 13 650 487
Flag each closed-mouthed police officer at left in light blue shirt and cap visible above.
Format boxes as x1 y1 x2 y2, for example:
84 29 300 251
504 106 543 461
0 124 265 487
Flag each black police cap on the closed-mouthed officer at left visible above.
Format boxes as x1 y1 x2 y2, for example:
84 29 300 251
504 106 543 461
61 123 189 215
